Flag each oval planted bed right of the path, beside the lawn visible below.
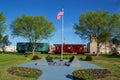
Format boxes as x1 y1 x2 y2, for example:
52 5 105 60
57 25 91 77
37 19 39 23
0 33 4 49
72 69 111 80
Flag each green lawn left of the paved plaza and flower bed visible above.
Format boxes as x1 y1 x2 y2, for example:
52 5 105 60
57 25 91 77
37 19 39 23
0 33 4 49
0 54 37 80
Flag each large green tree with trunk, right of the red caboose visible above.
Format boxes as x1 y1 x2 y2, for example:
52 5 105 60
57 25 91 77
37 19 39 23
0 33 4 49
74 10 120 55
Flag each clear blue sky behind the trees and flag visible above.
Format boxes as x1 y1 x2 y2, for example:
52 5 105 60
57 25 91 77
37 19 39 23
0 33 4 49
0 0 120 46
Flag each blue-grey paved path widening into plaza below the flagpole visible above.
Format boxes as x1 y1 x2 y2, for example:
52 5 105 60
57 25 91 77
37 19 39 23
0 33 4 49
19 60 102 80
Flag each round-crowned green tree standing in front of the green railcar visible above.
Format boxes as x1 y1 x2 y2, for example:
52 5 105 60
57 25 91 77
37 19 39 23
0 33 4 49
11 15 55 55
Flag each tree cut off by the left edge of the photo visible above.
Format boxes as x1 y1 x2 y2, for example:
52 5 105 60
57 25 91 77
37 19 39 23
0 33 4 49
0 13 10 52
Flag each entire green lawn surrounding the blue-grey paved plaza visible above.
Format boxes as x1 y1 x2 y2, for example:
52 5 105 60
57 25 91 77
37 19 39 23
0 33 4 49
0 54 120 80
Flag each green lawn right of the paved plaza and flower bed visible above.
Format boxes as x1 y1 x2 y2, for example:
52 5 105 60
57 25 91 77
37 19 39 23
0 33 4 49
92 55 120 80
